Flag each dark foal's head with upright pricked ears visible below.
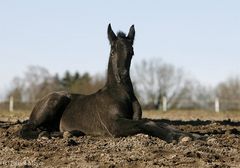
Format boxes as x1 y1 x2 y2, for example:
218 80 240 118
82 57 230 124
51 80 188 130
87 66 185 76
108 24 135 83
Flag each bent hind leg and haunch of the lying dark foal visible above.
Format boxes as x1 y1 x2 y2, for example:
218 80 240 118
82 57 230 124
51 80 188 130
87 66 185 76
20 92 71 138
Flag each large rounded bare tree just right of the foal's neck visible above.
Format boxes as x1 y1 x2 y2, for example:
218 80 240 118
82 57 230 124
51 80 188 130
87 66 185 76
133 59 186 108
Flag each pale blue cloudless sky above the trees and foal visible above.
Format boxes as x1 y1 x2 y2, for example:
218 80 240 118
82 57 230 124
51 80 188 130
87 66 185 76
0 0 240 98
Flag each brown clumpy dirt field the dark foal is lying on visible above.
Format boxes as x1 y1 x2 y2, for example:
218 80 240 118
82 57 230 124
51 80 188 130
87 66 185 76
0 111 240 168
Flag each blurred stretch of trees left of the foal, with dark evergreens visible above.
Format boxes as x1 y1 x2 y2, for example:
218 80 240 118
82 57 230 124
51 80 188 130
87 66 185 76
8 66 105 102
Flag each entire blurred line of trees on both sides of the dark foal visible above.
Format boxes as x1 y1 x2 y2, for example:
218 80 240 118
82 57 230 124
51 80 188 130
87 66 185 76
8 59 240 110
